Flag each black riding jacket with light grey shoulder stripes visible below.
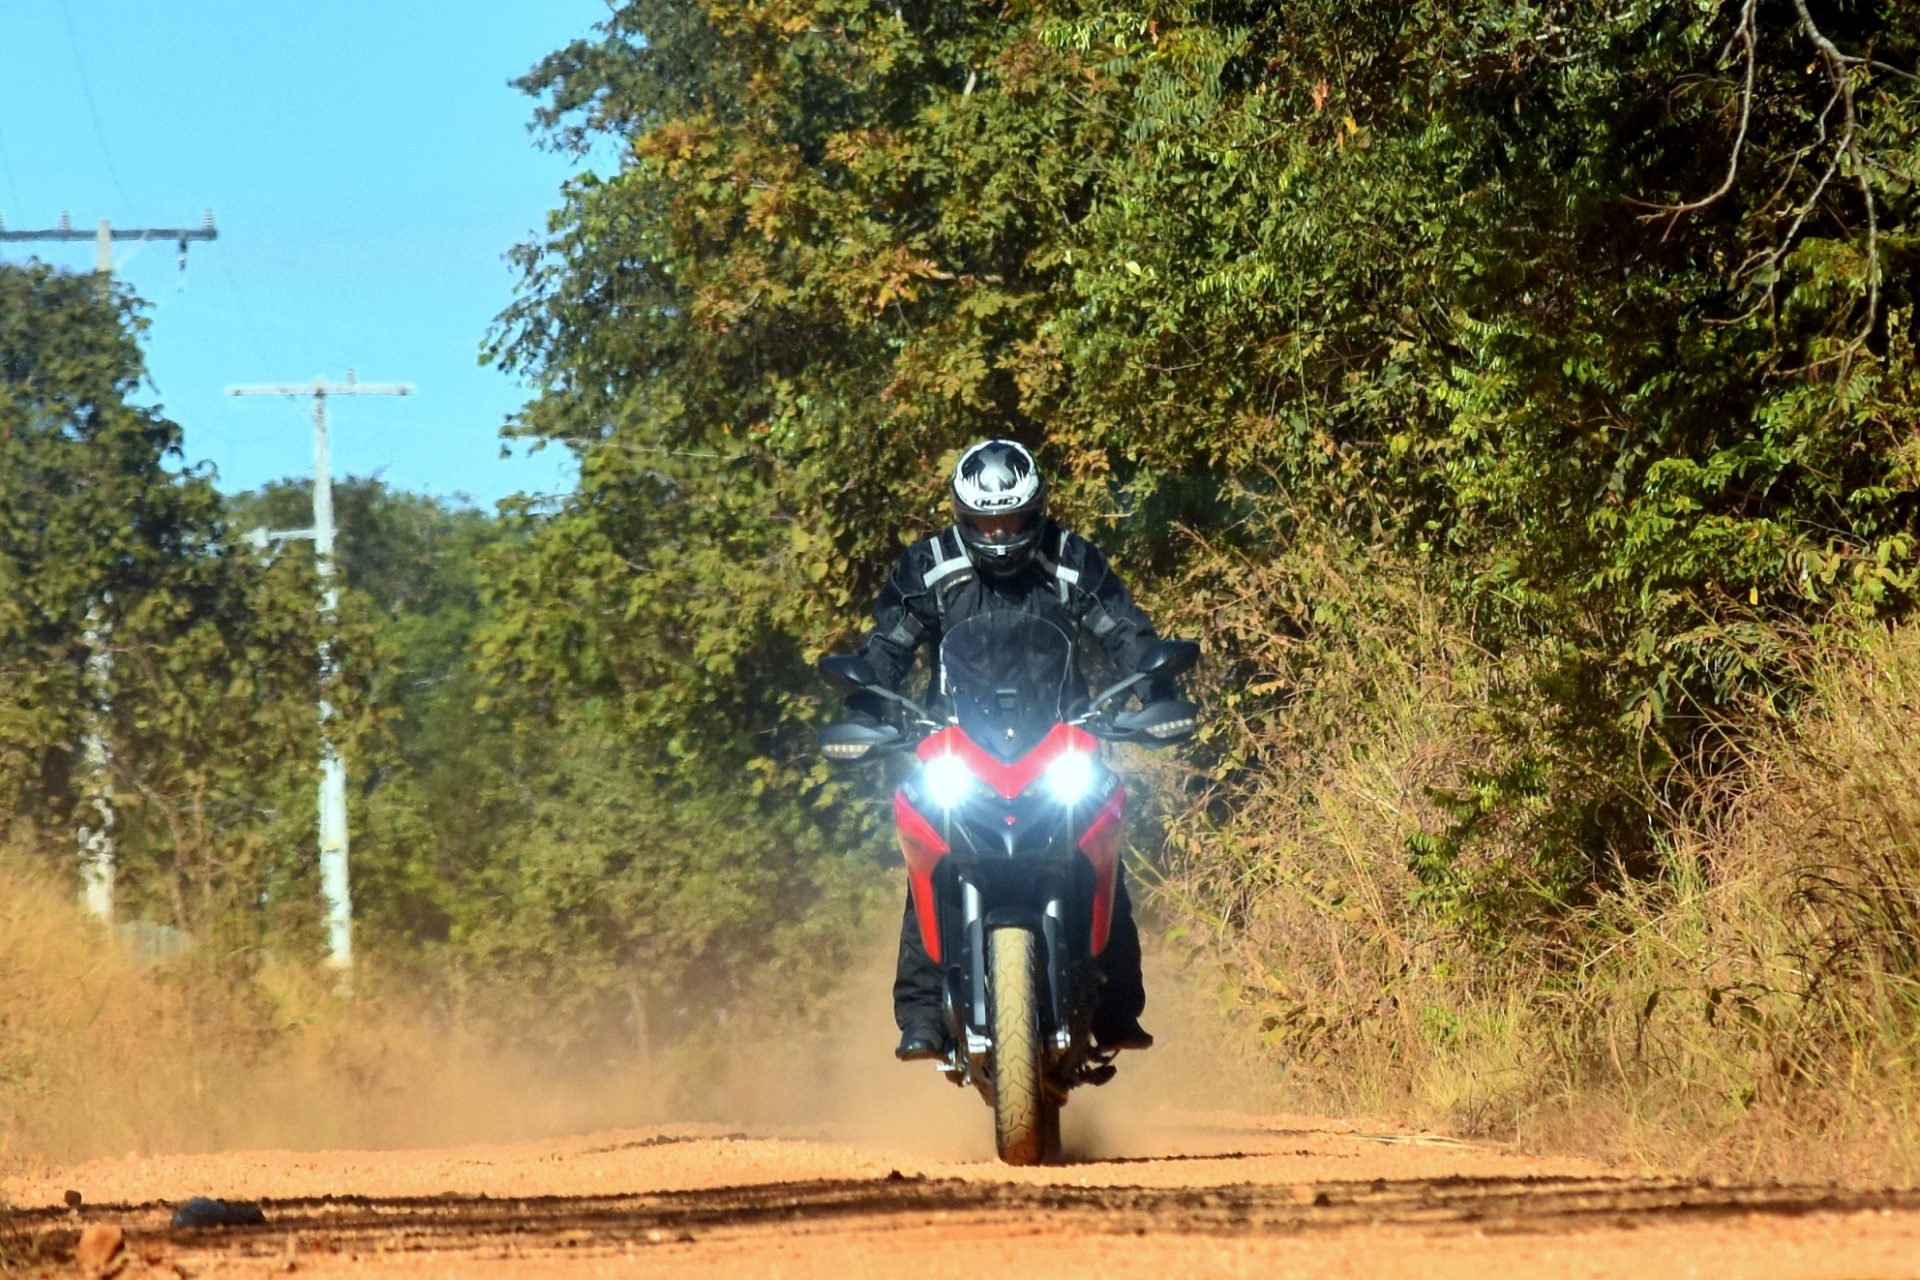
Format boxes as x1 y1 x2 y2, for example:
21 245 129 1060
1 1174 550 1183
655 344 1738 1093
849 520 1156 718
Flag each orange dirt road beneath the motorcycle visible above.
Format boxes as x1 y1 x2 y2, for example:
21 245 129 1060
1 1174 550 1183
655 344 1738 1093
6 1100 1920 1280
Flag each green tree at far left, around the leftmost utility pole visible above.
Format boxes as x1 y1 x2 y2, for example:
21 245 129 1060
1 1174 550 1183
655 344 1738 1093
0 265 345 954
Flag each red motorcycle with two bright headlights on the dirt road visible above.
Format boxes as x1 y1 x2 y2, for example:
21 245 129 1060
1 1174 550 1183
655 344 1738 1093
820 612 1200 1165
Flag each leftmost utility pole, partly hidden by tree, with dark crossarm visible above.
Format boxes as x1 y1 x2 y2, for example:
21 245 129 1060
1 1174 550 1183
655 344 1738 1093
0 209 219 925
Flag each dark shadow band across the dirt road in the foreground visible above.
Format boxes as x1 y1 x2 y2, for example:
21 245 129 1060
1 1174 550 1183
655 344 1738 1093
15 1153 1920 1263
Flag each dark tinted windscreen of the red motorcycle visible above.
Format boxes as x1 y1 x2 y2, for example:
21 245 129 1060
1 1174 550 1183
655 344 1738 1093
941 612 1073 764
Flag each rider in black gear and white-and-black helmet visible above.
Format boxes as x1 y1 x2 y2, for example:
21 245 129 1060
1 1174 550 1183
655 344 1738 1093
849 439 1173 1059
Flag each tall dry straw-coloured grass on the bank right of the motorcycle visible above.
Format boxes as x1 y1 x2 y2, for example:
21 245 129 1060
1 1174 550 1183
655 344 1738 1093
1154 529 1920 1182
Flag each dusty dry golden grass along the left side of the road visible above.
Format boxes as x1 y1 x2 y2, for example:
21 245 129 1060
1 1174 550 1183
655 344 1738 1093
0 860 675 1171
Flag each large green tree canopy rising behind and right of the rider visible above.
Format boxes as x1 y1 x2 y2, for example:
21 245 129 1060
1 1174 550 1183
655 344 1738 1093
490 0 1920 940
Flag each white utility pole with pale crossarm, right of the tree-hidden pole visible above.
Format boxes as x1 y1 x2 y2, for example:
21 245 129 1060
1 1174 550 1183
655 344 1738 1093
227 368 413 983
